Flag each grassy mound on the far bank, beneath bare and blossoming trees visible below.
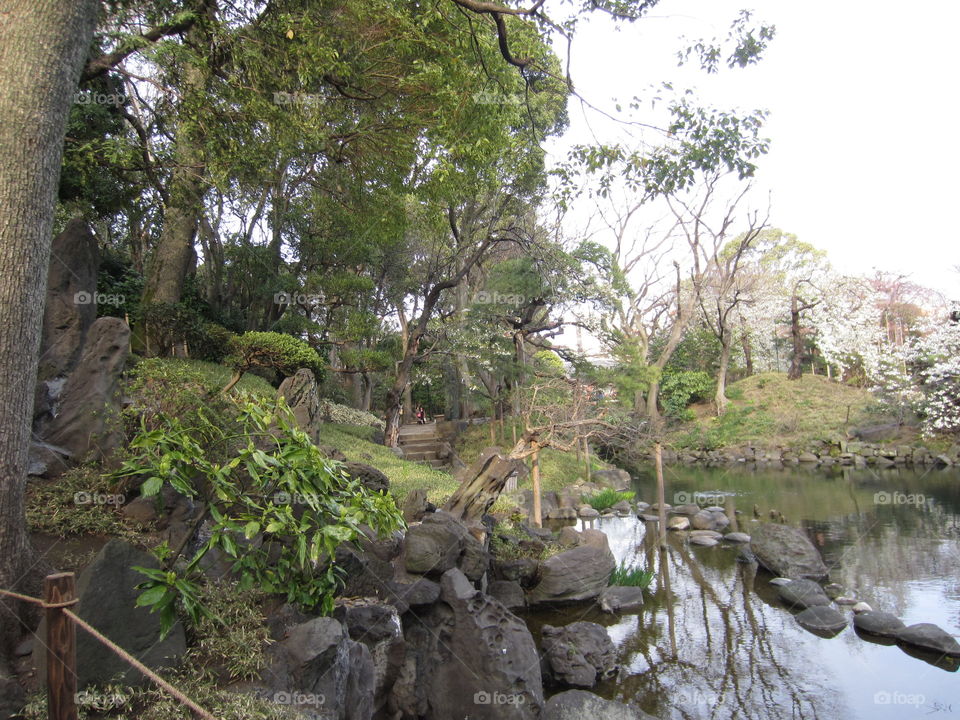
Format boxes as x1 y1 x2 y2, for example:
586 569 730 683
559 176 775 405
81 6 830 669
669 373 892 447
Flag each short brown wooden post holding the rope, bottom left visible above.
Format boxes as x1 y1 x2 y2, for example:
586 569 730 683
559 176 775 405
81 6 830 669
43 573 77 720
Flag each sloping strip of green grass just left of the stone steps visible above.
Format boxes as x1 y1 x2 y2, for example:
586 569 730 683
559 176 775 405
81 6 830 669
320 423 457 505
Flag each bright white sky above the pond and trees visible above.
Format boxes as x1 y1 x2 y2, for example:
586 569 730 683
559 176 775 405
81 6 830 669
550 0 960 298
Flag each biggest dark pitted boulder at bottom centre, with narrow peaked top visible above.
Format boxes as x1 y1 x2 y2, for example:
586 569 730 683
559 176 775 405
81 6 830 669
389 568 543 720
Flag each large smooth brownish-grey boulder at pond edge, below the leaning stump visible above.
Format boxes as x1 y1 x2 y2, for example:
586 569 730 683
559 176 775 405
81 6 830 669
527 530 616 605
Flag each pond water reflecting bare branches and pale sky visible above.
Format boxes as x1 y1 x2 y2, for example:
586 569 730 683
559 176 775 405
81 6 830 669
528 467 960 720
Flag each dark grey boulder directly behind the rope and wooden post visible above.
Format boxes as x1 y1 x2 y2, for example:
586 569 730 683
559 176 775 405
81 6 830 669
33 540 187 689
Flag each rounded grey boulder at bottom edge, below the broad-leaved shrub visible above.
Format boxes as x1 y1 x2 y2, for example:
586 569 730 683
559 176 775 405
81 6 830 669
259 617 376 720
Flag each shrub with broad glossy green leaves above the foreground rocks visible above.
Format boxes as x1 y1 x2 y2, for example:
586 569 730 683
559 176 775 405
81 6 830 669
116 394 403 632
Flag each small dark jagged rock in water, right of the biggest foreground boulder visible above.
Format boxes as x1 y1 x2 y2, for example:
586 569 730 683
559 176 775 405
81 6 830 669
542 621 617 688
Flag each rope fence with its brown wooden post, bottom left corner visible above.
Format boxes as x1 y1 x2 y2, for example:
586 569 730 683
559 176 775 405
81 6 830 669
0 573 217 720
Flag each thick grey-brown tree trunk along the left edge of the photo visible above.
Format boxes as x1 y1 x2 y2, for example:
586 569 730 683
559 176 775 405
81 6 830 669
0 0 98 612
